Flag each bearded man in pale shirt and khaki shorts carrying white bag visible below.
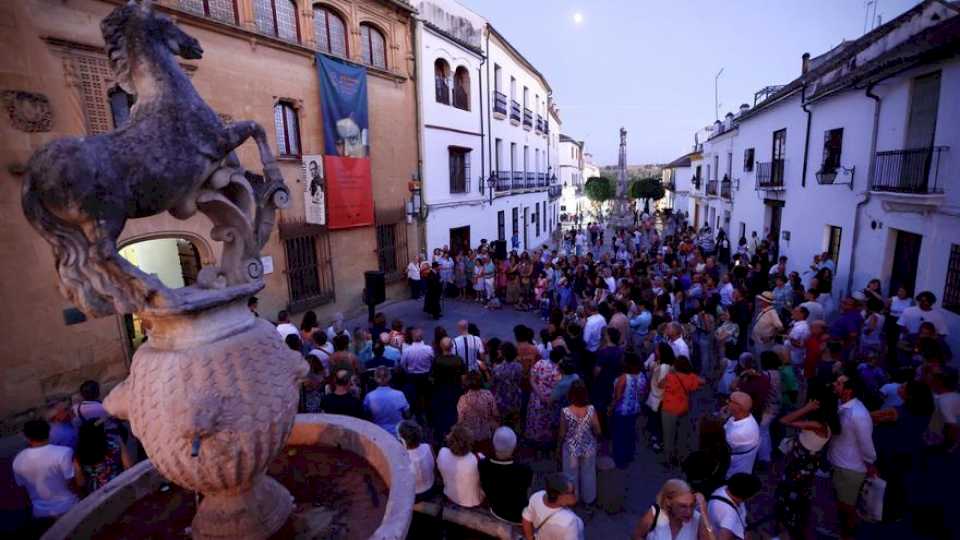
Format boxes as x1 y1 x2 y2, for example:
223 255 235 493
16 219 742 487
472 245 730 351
827 375 877 538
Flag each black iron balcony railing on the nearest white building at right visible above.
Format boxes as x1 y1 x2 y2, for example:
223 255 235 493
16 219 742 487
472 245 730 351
870 146 949 194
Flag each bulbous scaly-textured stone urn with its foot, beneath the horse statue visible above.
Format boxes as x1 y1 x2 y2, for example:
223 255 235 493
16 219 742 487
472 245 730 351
104 291 309 539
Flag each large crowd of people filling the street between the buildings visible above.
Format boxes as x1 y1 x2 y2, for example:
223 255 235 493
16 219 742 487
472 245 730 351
9 214 960 540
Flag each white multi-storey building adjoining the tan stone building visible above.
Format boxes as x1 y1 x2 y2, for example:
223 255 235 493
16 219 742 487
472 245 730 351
417 0 560 253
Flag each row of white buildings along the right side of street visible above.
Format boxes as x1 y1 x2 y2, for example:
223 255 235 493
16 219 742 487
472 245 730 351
672 1 960 356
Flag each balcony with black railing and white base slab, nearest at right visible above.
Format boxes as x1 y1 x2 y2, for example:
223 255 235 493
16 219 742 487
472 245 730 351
870 146 950 212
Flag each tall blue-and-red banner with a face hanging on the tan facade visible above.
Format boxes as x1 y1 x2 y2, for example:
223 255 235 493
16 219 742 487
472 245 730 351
317 54 374 229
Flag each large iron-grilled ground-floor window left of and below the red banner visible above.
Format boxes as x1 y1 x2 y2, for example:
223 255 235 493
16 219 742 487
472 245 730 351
278 220 335 312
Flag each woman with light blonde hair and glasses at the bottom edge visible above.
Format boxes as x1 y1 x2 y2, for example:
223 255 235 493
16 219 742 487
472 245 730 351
633 478 714 540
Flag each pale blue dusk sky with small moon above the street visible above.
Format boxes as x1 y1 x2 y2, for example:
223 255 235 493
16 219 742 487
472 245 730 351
459 0 918 165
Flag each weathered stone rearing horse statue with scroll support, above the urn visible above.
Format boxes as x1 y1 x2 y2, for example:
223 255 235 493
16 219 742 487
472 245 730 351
22 0 289 317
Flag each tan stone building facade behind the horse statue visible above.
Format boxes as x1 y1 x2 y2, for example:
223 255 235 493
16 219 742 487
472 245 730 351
0 0 419 429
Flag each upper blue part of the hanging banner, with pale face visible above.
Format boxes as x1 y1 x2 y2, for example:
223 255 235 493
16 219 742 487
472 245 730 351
317 53 370 158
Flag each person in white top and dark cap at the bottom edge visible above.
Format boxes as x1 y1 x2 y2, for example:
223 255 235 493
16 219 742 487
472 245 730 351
523 473 584 540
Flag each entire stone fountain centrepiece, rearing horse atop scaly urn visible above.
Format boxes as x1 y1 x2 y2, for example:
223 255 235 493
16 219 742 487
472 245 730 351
22 1 308 539
